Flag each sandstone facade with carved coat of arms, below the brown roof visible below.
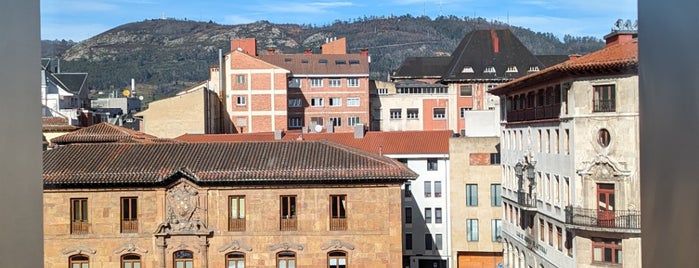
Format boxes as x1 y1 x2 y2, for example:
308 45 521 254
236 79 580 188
44 178 402 268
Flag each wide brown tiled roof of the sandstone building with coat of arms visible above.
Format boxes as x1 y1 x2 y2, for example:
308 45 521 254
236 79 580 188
43 141 417 188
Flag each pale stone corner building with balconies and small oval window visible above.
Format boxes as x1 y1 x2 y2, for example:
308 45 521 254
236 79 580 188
490 30 641 268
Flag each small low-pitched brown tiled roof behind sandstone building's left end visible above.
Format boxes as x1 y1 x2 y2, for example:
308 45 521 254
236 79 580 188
51 122 167 145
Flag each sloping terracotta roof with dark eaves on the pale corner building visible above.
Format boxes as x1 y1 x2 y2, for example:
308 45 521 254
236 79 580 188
490 39 638 95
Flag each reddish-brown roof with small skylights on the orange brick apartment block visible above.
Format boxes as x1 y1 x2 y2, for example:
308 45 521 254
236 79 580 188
258 54 369 76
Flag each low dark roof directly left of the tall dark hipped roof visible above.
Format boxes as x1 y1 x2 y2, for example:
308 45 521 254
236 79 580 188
391 57 451 79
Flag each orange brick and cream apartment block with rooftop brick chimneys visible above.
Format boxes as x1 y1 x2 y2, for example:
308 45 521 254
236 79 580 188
211 38 369 133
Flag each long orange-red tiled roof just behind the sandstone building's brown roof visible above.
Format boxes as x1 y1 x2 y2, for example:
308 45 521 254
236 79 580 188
175 130 452 154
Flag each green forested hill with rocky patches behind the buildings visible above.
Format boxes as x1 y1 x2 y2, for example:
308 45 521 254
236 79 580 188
42 15 604 101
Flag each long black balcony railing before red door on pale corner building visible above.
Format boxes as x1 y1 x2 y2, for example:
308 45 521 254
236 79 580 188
566 206 641 230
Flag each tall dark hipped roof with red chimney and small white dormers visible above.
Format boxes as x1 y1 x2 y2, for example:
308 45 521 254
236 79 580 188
442 29 546 82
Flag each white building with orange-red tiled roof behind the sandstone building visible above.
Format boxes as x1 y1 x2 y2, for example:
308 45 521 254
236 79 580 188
176 129 454 268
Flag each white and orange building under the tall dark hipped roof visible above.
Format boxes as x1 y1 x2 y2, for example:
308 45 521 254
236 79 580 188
388 29 568 134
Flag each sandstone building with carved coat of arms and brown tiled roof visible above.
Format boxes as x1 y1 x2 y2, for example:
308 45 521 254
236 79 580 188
43 141 417 268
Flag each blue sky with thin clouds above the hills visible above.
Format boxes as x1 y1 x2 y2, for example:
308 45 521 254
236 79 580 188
41 0 637 41
